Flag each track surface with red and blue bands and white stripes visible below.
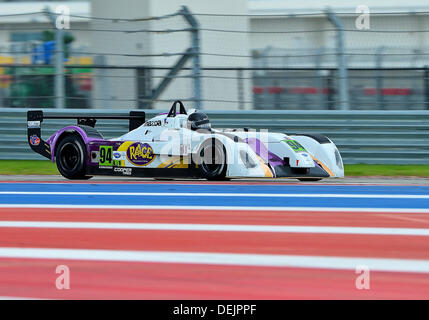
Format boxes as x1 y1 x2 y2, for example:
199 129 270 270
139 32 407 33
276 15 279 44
0 176 429 299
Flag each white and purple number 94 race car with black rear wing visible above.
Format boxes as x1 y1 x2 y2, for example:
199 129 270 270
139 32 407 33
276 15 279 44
27 101 344 181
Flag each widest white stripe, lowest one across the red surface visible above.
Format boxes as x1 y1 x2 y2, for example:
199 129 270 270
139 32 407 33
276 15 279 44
0 248 429 273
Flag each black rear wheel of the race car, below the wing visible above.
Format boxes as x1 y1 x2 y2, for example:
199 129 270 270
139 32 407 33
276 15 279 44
55 134 92 180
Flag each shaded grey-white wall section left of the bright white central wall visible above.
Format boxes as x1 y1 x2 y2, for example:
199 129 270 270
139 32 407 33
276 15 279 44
91 0 151 109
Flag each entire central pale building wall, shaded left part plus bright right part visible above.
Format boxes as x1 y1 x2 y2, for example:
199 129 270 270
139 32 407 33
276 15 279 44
91 0 251 109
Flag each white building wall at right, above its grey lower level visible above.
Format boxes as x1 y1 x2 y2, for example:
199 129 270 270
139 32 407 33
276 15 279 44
250 13 429 67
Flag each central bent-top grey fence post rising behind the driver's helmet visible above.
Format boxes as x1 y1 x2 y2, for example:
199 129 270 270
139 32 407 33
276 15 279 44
181 6 202 109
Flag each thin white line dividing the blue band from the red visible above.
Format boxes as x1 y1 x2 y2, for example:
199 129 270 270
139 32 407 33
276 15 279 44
0 203 429 214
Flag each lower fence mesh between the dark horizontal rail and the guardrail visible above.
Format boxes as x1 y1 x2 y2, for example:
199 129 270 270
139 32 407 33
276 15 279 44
0 65 429 110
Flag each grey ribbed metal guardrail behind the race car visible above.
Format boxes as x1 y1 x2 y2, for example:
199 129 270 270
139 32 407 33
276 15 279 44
0 108 429 164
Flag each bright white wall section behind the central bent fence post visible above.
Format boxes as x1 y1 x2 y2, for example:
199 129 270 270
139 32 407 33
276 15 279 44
151 0 252 110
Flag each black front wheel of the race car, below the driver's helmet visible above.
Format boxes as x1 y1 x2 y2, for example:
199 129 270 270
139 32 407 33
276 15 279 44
196 138 227 181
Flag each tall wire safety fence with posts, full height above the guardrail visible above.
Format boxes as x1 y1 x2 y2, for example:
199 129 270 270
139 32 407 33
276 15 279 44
0 8 429 110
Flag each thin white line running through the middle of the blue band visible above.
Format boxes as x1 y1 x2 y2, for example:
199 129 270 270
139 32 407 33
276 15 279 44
0 191 429 199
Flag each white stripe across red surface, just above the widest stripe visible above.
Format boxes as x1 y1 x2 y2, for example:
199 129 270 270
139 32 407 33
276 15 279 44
0 221 429 236
